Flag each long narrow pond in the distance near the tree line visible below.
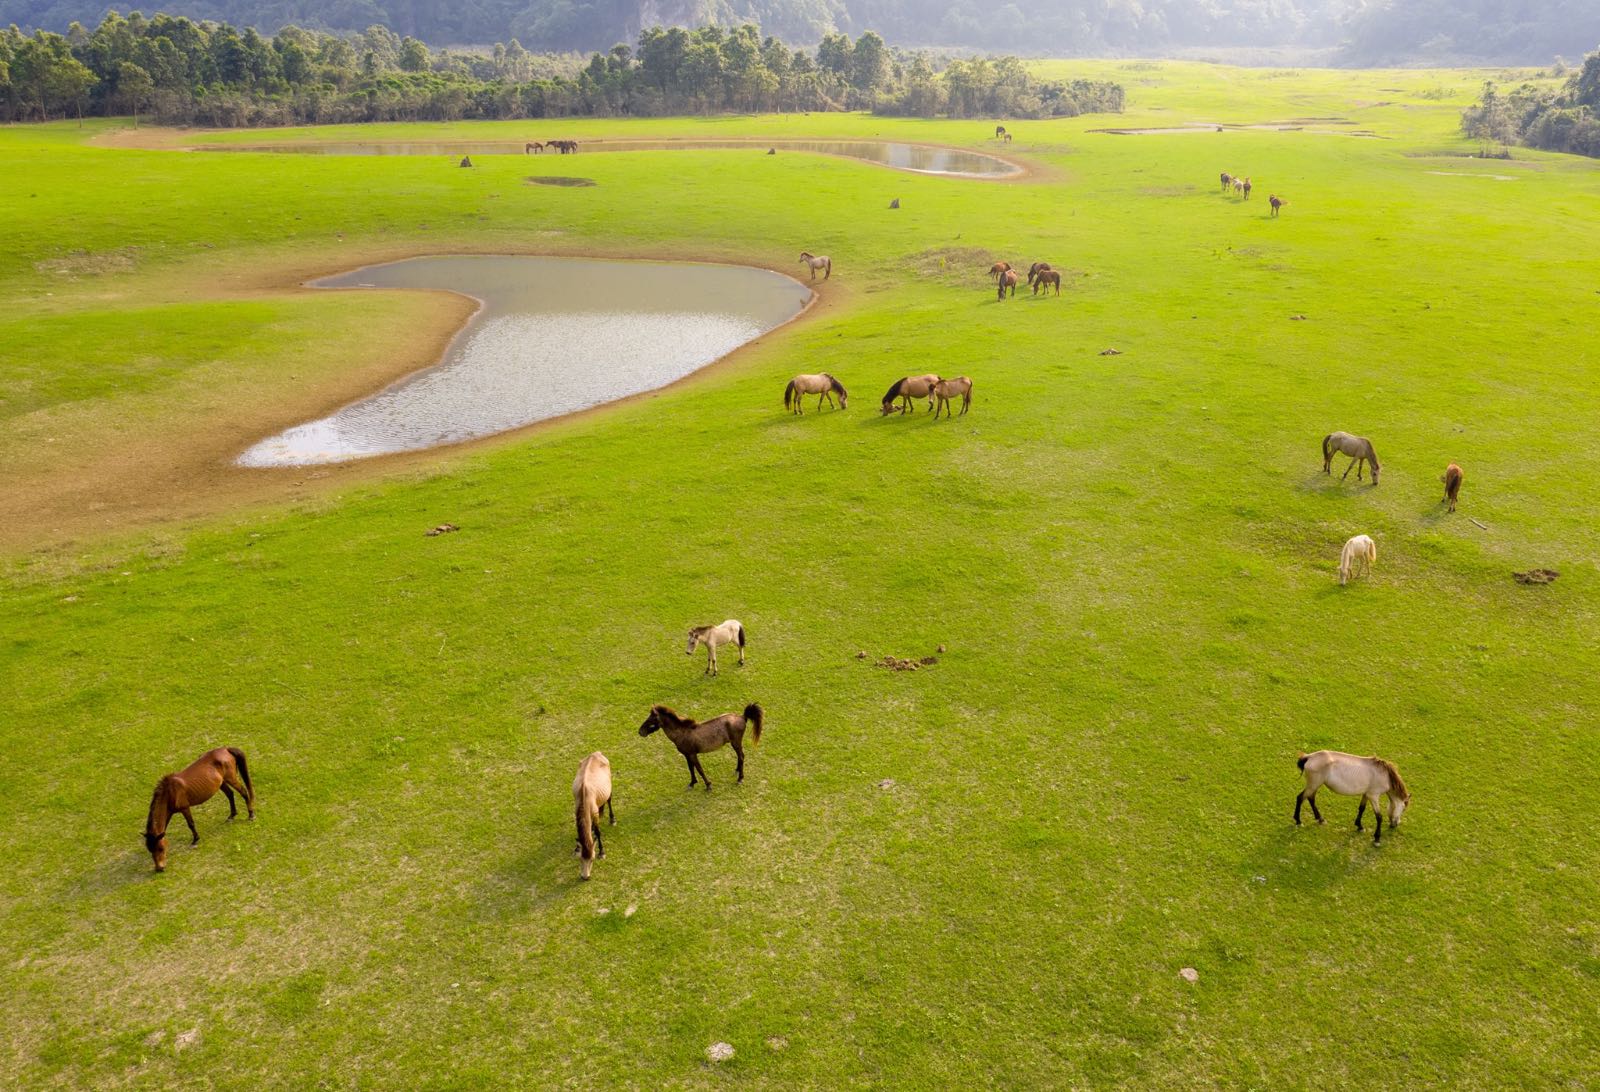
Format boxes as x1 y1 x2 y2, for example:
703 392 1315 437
203 141 1022 178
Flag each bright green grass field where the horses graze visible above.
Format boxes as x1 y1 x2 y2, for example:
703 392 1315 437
0 62 1600 1089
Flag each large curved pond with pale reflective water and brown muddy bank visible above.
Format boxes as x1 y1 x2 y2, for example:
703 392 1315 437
238 255 811 466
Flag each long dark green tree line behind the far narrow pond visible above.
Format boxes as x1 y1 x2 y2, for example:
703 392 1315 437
0 11 1123 126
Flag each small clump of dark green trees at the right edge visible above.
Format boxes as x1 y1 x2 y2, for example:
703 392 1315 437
1461 50 1600 157
